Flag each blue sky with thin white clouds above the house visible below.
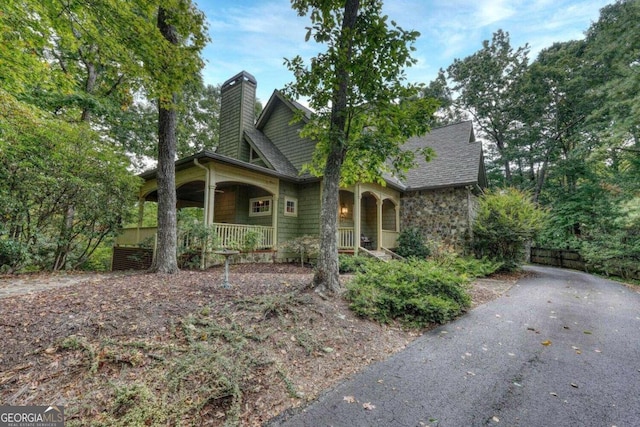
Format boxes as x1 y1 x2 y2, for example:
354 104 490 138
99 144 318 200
195 0 613 104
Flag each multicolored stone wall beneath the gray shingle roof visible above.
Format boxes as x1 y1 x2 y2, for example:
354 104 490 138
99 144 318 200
400 187 477 252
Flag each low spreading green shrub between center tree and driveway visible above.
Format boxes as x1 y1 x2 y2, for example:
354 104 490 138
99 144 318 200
346 260 471 328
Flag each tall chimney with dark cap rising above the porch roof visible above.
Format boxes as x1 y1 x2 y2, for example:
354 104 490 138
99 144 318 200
216 71 257 161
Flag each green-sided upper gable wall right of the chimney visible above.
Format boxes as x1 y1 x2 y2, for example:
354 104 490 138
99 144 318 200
262 103 315 170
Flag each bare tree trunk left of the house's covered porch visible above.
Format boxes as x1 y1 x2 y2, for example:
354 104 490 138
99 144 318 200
150 7 179 274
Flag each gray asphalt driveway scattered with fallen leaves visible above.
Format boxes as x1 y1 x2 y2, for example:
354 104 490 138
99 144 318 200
271 267 640 427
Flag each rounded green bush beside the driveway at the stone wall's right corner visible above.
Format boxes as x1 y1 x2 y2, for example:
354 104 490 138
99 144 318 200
473 188 546 270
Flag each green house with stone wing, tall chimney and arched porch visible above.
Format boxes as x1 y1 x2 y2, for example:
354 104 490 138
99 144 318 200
116 71 486 270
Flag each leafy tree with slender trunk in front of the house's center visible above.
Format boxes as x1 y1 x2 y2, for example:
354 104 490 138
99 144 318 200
286 0 436 292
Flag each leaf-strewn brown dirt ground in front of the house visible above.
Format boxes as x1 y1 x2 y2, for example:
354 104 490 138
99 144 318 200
0 264 516 426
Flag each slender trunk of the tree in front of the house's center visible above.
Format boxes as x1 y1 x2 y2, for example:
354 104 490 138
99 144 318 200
313 0 360 293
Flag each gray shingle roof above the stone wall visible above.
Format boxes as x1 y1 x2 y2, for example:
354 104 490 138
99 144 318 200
404 121 484 190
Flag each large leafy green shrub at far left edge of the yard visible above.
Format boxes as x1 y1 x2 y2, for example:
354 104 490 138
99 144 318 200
0 90 139 271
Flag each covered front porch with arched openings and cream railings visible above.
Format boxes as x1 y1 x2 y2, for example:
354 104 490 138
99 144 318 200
115 155 400 266
